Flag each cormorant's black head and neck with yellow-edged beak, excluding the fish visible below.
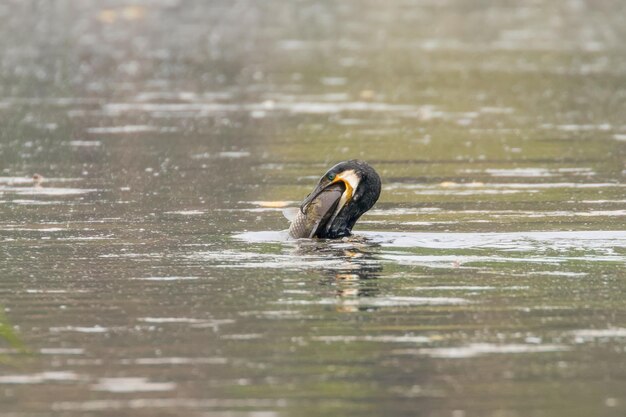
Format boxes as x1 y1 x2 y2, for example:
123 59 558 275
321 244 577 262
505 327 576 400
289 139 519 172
300 159 381 238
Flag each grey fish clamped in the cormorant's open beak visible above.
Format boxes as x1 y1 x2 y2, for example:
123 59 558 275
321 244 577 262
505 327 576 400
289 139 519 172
283 183 345 239
